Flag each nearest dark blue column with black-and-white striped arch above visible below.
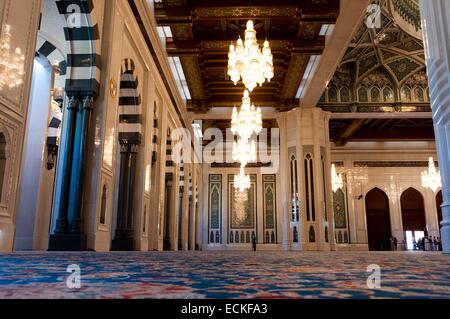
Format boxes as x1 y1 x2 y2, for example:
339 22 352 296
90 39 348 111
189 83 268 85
49 0 101 251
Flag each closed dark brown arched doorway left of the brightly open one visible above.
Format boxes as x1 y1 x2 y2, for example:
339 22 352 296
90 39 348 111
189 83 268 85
366 188 391 251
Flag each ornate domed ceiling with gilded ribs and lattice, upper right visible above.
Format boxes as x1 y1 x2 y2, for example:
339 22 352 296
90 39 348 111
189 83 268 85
319 0 430 112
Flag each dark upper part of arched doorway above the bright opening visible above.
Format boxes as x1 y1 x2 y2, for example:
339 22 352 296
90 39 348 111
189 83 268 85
400 188 426 232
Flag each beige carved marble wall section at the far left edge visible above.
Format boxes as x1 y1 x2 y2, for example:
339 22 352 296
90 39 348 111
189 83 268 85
0 0 42 251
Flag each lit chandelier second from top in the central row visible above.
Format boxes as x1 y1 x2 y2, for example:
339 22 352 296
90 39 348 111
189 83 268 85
231 90 262 140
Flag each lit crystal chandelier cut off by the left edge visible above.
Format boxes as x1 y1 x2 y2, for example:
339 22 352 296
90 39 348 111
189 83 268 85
0 24 25 90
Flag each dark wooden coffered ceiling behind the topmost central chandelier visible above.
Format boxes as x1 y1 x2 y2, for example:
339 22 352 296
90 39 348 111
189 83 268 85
155 0 339 113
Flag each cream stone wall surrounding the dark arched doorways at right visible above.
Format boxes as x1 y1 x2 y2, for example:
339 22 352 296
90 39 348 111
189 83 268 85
331 142 439 250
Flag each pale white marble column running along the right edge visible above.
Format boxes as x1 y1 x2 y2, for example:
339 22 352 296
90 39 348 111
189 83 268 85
420 0 450 253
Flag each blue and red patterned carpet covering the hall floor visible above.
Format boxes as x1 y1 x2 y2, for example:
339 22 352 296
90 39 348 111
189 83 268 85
0 252 450 299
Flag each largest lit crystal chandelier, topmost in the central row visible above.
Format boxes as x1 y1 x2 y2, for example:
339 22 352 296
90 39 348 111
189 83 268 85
228 20 274 92
